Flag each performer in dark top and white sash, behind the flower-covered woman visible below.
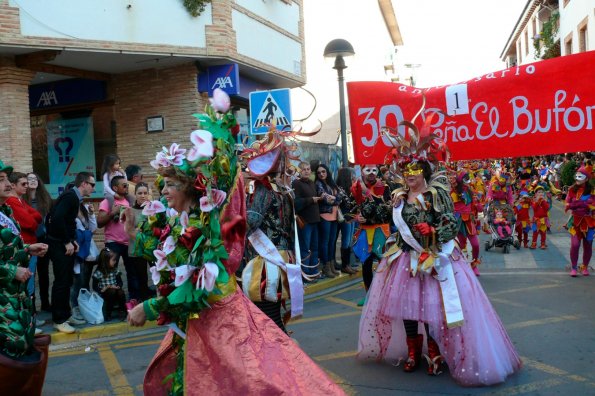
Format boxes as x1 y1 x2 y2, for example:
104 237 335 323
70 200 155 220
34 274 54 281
241 127 303 333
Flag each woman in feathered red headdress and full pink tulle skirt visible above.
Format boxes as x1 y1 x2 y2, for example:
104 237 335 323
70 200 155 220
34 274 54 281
358 118 521 386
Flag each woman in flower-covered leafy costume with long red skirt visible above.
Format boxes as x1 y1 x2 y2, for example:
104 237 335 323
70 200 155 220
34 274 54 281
125 90 343 395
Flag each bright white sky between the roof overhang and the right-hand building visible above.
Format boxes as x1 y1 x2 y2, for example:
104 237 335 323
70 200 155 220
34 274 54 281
393 0 527 87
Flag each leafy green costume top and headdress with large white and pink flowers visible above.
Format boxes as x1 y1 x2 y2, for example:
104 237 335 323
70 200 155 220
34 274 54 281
135 89 246 394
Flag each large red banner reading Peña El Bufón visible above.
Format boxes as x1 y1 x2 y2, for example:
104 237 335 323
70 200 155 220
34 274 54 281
347 51 595 164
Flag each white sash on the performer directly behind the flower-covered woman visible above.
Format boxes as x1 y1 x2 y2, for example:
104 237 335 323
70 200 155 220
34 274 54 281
248 228 304 318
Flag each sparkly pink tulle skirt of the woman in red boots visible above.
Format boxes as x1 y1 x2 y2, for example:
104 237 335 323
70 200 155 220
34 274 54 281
358 249 521 386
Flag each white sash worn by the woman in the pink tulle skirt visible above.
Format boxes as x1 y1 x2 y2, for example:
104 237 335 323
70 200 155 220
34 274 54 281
393 201 465 328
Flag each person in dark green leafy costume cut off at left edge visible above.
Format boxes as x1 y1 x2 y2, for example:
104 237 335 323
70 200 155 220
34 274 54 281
0 161 51 396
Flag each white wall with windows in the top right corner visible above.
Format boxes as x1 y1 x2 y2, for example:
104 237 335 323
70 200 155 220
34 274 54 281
559 0 595 55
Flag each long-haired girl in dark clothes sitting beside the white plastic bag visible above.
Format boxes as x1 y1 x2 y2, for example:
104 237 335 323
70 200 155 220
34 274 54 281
93 248 126 321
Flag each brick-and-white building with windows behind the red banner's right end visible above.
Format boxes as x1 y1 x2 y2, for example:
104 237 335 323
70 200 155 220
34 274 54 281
500 0 595 67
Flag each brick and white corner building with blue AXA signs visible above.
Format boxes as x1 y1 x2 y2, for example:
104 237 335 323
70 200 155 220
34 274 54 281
0 0 306 192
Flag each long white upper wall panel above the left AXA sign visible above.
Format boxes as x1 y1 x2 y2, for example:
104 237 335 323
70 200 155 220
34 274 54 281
9 0 212 47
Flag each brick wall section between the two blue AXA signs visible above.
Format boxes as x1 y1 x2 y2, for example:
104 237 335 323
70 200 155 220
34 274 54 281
110 63 206 180
